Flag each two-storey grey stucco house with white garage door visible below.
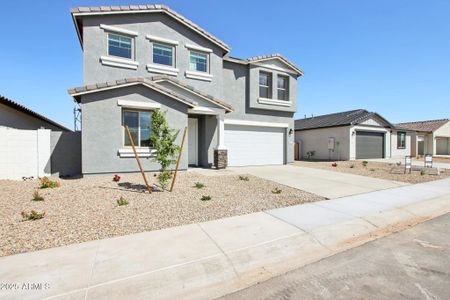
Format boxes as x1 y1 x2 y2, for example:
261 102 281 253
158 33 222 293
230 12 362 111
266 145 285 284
69 5 303 175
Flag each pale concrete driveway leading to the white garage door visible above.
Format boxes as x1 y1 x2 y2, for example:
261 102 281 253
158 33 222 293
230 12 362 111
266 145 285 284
229 165 408 199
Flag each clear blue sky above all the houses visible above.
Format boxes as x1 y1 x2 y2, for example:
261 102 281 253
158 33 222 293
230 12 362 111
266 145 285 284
0 0 450 128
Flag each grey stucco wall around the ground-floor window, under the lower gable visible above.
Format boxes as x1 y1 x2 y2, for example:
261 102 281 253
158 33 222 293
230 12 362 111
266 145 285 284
82 86 188 175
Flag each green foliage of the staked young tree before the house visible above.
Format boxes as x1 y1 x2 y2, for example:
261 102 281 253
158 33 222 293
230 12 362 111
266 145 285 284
149 109 180 189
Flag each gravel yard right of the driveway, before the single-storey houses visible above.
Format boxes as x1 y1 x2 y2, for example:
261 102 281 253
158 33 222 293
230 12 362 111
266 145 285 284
294 160 450 184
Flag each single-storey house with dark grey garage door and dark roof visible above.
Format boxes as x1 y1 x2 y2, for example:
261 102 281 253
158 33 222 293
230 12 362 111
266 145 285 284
295 109 413 160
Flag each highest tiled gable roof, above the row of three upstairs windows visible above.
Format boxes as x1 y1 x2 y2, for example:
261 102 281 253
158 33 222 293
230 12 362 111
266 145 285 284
70 4 231 53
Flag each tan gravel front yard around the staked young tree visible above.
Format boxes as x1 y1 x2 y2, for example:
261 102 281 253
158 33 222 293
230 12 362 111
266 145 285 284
0 172 323 256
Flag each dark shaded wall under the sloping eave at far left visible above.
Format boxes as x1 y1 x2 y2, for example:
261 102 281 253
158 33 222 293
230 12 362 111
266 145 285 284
0 104 62 131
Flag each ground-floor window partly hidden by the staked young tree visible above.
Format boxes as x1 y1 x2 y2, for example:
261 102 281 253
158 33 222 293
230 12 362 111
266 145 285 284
123 110 151 147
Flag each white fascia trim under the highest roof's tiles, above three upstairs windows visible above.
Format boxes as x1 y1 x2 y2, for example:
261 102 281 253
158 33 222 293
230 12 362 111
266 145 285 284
72 9 230 52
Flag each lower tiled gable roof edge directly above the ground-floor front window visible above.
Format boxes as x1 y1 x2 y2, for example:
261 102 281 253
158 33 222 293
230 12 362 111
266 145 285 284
68 77 198 108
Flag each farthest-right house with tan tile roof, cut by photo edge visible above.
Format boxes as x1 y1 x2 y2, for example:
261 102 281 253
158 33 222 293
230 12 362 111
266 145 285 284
396 119 450 156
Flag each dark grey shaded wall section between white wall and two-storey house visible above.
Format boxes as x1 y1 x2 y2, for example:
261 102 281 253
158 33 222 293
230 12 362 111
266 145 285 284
50 131 81 176
